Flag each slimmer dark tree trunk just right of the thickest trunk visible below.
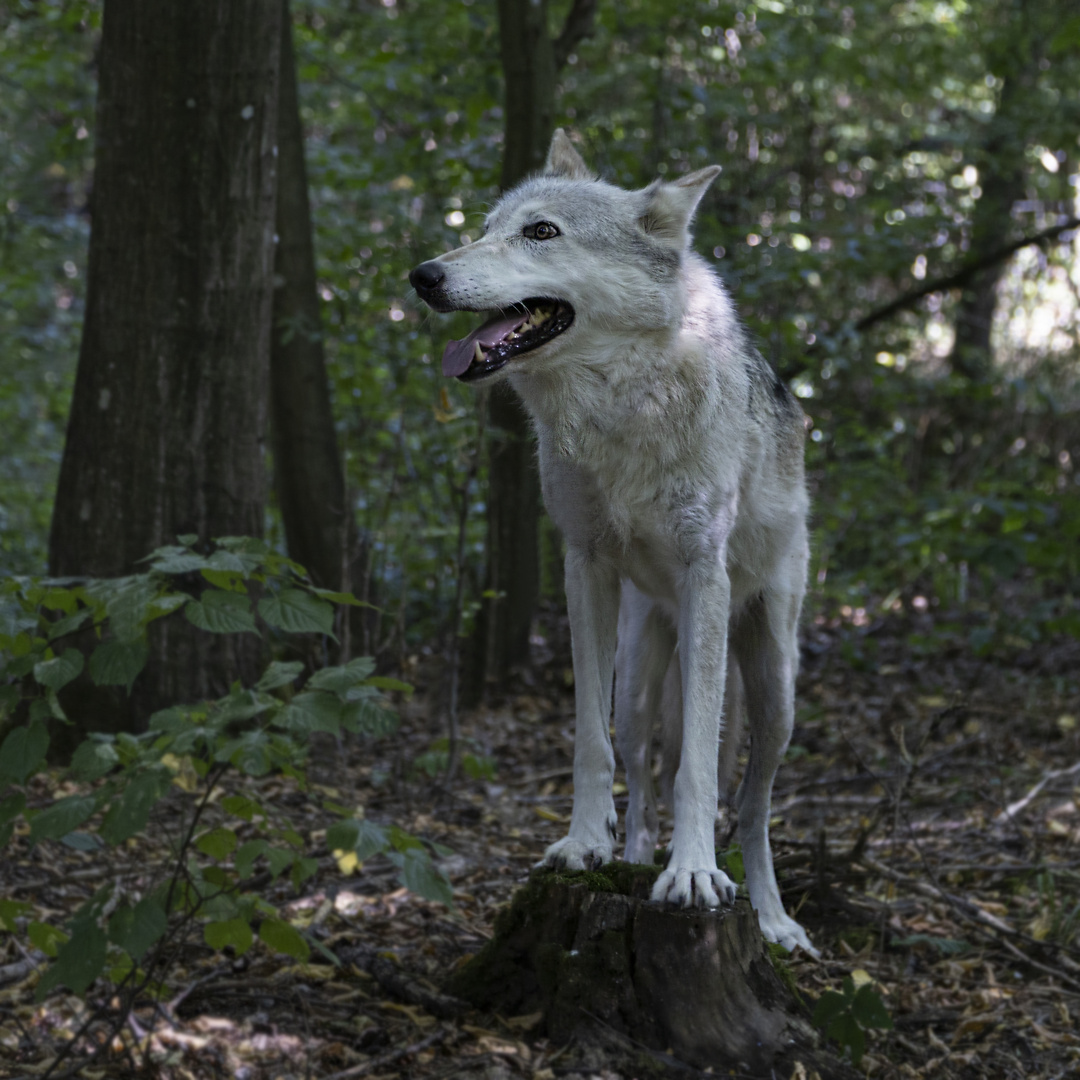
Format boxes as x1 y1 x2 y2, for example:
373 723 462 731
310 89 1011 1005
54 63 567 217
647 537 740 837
270 0 350 590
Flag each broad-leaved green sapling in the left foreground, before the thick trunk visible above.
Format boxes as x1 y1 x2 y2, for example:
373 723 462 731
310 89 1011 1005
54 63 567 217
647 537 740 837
0 537 450 1013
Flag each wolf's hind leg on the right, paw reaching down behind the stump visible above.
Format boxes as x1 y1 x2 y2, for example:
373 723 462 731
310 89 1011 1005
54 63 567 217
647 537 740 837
731 592 819 956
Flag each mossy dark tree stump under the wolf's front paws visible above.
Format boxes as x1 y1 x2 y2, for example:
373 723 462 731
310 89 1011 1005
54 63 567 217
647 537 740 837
447 863 854 1077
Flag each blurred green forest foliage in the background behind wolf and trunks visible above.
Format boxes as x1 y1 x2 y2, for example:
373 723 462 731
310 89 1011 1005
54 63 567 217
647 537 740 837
0 0 1080 656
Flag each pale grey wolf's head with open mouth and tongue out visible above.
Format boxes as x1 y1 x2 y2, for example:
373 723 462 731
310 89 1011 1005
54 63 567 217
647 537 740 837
409 129 720 381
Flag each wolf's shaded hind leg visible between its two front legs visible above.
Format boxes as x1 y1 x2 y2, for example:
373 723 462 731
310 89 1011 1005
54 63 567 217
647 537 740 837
615 582 681 863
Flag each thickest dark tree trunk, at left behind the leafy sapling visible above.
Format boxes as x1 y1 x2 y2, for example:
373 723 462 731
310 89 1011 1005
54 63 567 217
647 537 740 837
50 0 281 723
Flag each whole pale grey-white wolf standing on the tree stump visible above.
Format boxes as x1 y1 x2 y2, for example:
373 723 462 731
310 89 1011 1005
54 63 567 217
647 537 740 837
409 130 815 953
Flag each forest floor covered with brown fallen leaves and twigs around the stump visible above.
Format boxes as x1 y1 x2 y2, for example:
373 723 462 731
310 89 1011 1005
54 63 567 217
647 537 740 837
0 613 1080 1080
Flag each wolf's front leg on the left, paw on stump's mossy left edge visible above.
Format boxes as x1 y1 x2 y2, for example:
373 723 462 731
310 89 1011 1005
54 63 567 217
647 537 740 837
541 548 619 869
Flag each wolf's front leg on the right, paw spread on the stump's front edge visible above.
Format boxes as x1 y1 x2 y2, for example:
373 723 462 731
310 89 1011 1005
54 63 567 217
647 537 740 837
652 558 735 907
